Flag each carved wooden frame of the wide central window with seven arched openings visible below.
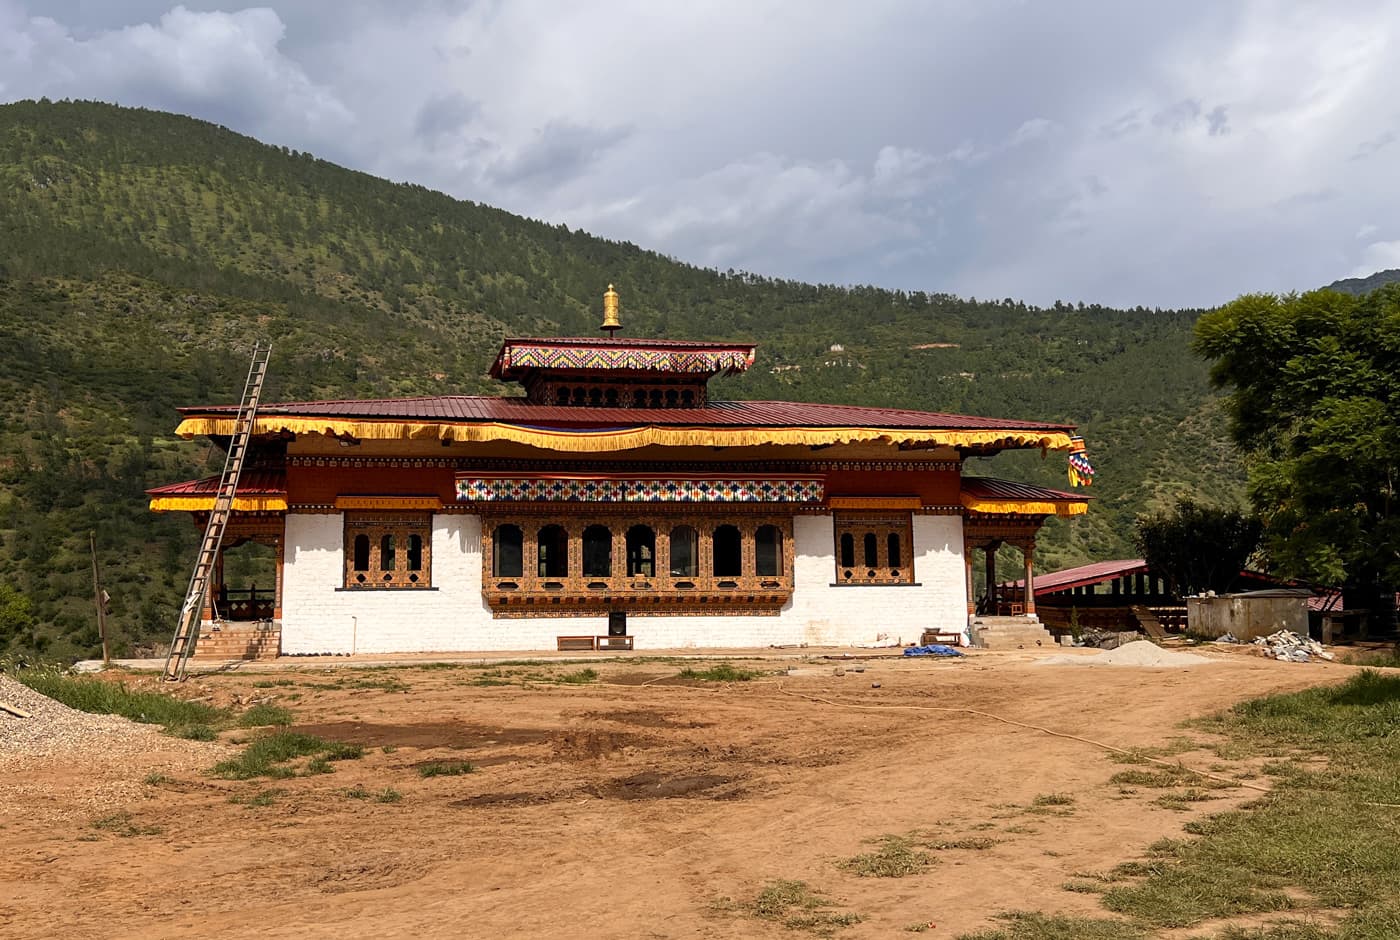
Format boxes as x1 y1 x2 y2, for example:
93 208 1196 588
482 507 794 618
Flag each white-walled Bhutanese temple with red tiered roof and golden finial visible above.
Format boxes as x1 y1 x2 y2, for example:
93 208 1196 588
148 287 1086 657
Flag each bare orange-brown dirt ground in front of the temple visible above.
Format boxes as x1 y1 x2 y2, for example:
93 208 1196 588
0 650 1351 940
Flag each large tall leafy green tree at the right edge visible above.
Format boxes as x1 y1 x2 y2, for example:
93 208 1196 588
1194 284 1400 616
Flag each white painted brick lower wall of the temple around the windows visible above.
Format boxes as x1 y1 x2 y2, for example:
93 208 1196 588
281 514 967 654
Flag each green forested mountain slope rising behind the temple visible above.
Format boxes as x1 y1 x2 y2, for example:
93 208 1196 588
0 102 1242 656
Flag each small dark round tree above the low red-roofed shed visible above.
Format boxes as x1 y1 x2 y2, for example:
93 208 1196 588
1133 499 1260 597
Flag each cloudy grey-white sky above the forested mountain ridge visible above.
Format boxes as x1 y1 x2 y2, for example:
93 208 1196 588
0 0 1400 307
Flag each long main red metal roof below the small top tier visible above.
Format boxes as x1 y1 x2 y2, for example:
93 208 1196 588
178 395 1084 434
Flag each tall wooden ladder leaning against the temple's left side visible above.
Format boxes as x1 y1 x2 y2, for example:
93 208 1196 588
165 343 272 682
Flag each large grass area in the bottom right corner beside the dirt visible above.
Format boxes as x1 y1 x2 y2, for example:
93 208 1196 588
1105 671 1400 940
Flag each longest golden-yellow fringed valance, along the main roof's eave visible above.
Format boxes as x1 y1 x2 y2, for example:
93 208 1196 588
175 415 1070 454
